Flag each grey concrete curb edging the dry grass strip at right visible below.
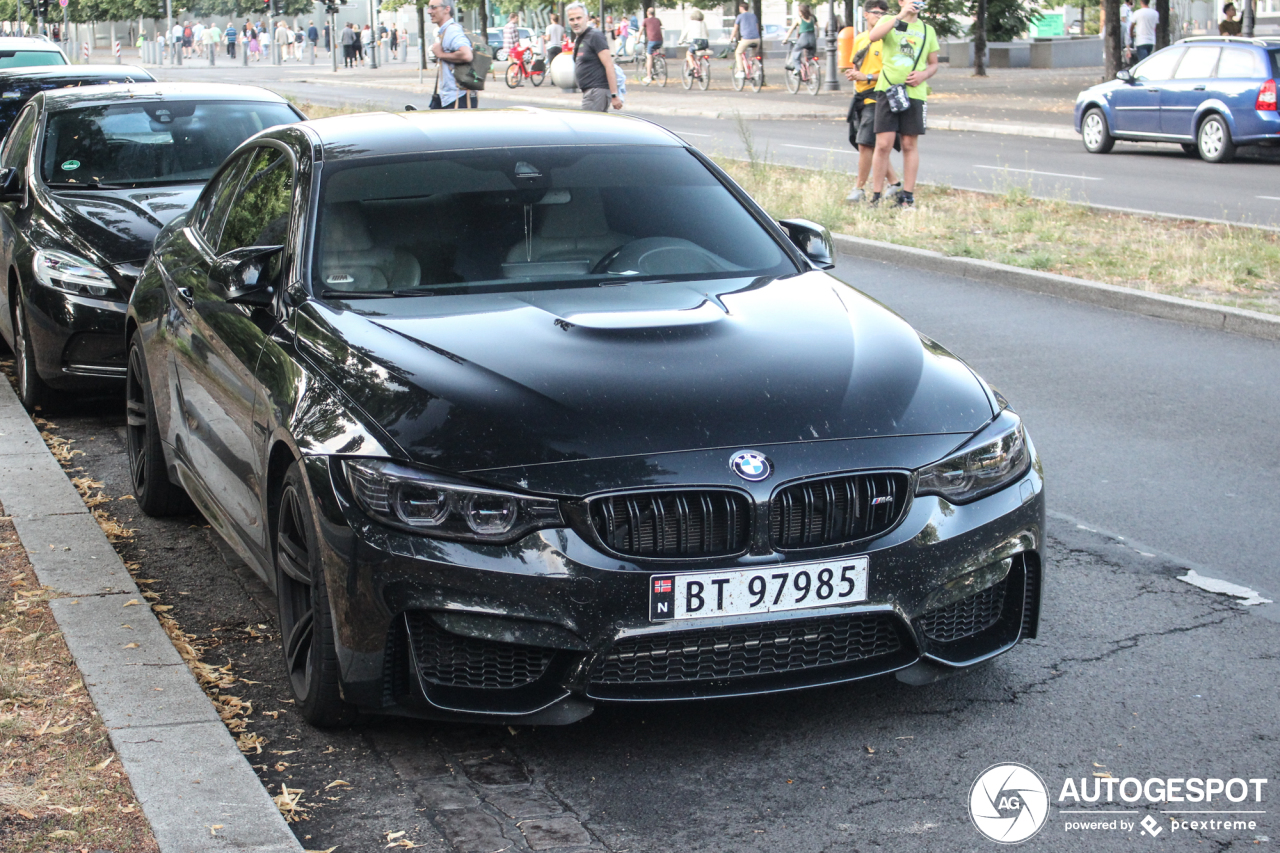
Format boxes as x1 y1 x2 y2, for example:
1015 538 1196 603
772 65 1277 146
832 234 1280 341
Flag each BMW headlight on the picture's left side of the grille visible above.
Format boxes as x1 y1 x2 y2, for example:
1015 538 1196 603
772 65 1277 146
343 459 564 543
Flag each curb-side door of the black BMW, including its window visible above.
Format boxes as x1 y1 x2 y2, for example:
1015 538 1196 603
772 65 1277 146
174 140 296 562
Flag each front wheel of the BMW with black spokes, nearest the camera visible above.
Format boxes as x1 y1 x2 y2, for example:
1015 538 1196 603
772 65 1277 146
275 462 356 727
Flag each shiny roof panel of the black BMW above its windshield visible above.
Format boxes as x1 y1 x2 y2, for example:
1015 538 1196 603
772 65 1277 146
302 106 685 160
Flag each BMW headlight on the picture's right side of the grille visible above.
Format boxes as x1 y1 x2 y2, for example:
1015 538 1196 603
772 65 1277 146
915 409 1032 503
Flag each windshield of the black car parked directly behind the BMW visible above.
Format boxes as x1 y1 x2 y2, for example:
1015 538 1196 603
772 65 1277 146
41 101 298 188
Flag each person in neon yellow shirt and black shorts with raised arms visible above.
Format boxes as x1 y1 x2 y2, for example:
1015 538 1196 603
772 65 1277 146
867 0 938 209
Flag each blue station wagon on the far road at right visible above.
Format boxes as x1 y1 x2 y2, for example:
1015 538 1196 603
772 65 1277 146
1075 36 1280 163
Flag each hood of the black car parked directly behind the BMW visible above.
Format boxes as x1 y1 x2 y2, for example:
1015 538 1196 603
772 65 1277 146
49 183 205 264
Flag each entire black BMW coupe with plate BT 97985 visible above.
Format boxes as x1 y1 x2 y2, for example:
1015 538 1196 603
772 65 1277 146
127 109 1044 725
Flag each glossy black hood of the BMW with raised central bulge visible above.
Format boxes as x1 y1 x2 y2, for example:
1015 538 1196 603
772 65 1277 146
296 272 993 471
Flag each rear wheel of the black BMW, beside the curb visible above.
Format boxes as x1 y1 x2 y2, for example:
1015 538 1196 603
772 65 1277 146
124 336 196 519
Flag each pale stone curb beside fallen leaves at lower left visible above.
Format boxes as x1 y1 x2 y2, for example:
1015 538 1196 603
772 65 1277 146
0 382 302 853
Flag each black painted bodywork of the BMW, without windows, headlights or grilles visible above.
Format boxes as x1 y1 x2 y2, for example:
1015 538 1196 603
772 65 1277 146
129 111 1044 722
